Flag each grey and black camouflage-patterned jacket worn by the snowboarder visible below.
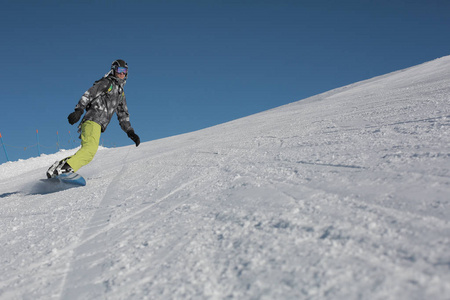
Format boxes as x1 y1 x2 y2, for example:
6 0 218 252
75 76 133 132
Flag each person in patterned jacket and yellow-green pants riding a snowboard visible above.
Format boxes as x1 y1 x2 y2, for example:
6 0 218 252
47 59 140 178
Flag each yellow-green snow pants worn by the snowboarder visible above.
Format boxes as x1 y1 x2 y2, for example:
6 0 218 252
67 121 102 172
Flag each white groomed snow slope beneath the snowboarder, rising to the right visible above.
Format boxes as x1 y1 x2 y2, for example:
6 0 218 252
0 56 450 300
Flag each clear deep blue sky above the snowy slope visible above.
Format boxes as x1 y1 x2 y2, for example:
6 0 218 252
0 0 450 163
